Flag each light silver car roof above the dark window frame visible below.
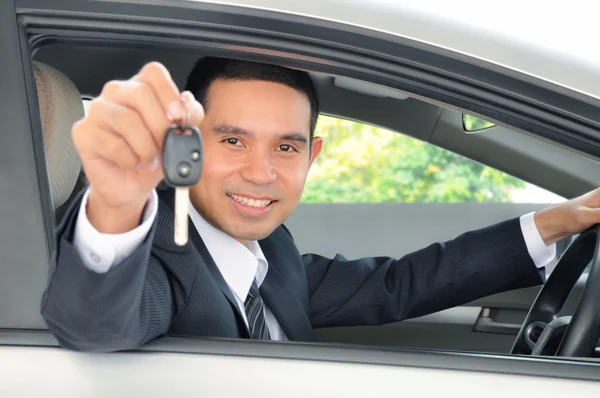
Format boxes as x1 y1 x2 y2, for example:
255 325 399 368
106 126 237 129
190 0 600 99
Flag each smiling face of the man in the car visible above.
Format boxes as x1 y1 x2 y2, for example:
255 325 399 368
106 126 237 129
190 80 323 243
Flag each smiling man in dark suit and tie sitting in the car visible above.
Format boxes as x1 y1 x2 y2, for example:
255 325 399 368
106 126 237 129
42 58 600 351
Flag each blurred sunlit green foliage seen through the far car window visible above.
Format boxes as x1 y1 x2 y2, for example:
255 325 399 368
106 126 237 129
302 116 525 203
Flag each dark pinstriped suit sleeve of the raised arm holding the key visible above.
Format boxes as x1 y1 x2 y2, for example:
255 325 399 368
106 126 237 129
41 188 195 352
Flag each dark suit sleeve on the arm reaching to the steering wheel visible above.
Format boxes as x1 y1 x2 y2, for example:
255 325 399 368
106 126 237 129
303 218 544 328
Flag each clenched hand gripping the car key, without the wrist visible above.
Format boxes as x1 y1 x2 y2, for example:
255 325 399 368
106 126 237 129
73 62 204 170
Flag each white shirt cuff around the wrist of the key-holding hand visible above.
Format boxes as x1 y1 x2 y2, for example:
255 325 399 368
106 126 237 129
73 189 158 273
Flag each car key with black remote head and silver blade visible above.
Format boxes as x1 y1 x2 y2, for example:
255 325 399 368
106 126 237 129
162 99 203 246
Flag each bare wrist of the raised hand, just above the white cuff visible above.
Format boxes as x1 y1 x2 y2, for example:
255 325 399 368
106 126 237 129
85 189 148 234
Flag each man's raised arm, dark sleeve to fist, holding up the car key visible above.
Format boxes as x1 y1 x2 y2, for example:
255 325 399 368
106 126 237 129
42 62 204 351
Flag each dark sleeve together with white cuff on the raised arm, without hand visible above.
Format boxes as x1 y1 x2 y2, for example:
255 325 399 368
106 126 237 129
42 190 181 351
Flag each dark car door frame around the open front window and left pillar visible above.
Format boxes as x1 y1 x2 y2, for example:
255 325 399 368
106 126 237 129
0 0 600 391
